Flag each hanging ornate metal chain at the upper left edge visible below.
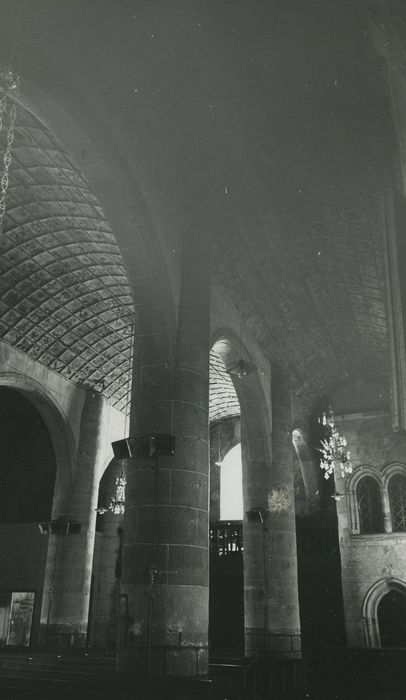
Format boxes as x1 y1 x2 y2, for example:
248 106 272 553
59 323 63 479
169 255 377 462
0 68 20 233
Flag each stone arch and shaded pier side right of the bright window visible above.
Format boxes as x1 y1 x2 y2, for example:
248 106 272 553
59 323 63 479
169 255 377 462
212 328 272 657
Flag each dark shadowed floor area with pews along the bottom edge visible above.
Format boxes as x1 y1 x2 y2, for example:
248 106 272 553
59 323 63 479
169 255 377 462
0 649 406 700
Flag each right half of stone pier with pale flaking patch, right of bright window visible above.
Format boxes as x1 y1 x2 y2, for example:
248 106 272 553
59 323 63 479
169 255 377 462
265 365 301 658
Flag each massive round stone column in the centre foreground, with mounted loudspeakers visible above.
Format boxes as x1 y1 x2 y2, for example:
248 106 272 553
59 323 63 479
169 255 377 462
117 221 210 677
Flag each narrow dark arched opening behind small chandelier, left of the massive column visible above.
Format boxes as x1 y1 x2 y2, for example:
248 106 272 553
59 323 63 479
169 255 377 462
89 459 124 650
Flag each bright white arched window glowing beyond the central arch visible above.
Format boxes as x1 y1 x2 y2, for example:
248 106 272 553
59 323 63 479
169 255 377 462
220 444 243 520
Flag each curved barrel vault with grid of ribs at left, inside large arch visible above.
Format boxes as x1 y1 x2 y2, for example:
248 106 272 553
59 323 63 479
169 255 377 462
0 107 134 408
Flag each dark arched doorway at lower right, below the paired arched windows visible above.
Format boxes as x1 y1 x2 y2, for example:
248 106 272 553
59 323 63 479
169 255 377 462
378 588 406 647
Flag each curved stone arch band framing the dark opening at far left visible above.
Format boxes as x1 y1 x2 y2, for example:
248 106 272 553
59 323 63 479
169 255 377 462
0 372 76 511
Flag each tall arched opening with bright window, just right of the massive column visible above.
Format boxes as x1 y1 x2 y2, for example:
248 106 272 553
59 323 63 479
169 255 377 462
209 348 244 660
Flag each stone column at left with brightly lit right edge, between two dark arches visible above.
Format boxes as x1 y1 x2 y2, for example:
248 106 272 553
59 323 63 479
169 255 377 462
40 392 105 647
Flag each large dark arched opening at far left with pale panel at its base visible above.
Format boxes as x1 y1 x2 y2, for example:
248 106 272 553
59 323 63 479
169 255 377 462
0 386 56 647
